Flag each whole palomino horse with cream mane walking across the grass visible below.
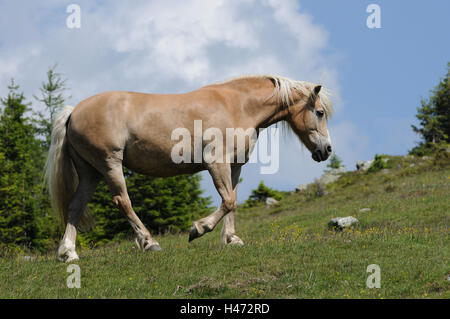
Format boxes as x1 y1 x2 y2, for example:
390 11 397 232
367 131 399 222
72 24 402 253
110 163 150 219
46 75 332 262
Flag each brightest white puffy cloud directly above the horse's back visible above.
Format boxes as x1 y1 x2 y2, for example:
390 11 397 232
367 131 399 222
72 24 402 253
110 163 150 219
89 0 337 89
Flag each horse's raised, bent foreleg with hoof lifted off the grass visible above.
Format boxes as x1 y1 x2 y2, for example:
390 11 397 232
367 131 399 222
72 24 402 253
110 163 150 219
189 163 239 241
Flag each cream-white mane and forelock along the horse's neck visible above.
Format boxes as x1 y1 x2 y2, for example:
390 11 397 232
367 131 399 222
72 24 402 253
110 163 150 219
220 74 333 118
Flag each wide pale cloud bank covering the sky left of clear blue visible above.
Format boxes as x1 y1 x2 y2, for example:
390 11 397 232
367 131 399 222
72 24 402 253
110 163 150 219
0 0 356 205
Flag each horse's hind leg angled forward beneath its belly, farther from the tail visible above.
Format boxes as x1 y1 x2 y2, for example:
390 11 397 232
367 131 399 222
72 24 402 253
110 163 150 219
105 164 161 251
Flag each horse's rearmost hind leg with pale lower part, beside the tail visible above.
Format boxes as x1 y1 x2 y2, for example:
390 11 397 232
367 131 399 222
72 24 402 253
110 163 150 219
57 148 100 262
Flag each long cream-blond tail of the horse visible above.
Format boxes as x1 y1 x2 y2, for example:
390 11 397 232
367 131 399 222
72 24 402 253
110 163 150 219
45 106 93 230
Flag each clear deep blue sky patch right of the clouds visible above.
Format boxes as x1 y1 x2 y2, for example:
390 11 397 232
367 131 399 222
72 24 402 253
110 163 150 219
303 1 450 154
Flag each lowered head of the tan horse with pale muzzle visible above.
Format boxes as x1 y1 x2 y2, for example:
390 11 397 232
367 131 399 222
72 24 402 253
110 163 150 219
286 85 332 162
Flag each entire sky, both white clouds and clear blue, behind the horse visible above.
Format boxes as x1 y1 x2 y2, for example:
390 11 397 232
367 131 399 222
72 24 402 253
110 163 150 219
0 0 450 204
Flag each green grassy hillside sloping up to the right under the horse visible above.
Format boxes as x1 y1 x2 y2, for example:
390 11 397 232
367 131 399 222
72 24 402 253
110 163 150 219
0 153 450 298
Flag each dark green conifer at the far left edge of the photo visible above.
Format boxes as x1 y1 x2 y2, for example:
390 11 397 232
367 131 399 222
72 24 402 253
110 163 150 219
0 80 41 252
